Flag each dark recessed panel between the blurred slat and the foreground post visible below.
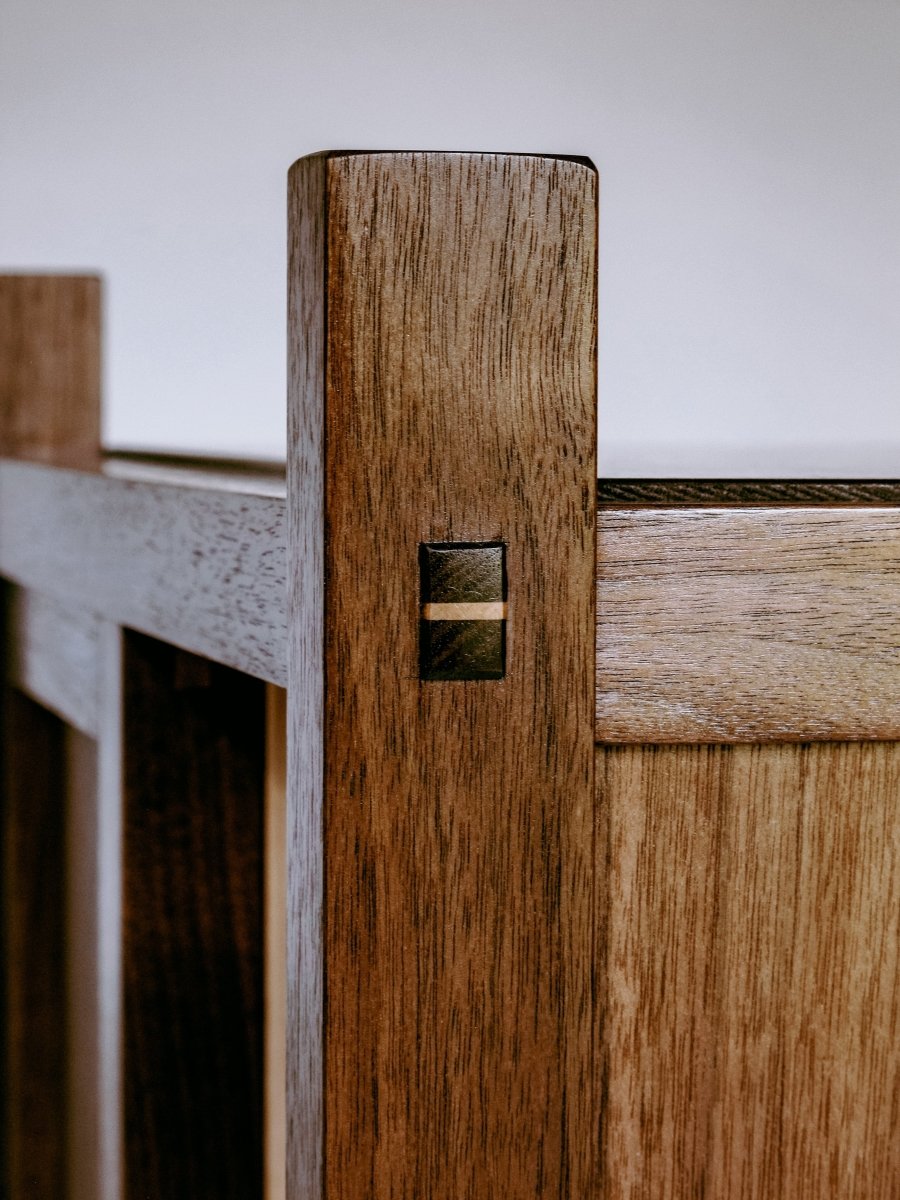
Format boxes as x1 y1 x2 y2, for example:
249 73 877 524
122 634 265 1200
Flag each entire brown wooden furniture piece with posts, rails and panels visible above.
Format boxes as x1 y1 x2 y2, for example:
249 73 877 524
0 152 900 1200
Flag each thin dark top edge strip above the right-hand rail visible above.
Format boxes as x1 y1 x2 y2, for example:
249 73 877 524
596 479 900 509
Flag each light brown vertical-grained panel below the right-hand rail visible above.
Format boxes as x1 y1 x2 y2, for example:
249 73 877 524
596 744 900 1200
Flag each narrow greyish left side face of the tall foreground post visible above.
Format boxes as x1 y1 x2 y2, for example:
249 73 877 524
286 155 328 1200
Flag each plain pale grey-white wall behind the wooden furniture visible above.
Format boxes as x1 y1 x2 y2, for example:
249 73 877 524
0 0 900 476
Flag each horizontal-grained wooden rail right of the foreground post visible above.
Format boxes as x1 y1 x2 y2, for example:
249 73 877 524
596 509 900 743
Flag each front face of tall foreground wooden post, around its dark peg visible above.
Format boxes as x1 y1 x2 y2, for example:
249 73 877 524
288 154 596 1200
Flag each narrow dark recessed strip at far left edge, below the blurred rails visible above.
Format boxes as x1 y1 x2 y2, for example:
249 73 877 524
0 689 67 1200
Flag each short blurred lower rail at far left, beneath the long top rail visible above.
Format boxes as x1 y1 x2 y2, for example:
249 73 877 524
6 587 101 737
